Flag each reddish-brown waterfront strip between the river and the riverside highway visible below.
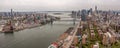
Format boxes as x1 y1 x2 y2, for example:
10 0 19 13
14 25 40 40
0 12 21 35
48 27 74 48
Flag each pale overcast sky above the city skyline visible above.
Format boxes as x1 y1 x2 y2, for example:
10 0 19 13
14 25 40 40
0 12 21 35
0 0 120 11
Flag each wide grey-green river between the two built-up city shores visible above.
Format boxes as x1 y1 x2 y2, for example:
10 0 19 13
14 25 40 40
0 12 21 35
0 12 77 48
